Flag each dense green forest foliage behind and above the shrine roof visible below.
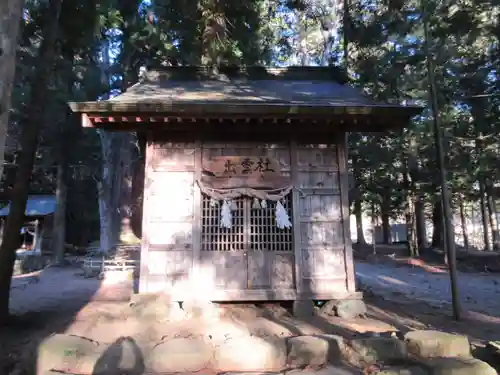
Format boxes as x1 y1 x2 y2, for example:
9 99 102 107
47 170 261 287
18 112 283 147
3 0 500 247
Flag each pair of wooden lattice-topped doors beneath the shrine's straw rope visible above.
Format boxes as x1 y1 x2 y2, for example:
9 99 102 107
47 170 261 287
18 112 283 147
201 195 294 289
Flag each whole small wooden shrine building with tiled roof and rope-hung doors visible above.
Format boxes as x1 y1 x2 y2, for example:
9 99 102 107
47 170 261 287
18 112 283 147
70 67 420 301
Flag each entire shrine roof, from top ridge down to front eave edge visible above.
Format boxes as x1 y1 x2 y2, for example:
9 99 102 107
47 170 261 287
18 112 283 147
69 67 421 118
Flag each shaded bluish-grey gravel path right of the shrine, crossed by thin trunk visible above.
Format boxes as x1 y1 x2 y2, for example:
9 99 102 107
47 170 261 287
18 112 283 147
356 262 500 316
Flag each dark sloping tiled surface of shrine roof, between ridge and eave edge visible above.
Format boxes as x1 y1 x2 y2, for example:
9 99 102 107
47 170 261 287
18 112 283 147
111 71 381 107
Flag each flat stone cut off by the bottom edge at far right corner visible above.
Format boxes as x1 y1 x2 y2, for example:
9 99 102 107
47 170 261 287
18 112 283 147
426 358 497 375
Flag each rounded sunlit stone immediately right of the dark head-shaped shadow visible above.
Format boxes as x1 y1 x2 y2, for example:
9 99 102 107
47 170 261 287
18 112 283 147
146 338 213 373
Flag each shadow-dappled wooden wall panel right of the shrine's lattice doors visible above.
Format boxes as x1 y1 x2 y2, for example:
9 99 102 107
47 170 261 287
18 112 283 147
292 144 347 295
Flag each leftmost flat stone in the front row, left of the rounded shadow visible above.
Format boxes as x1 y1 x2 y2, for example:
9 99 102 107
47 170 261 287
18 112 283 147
36 334 103 374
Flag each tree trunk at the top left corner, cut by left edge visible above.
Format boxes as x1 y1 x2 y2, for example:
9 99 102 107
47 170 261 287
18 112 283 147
0 0 24 182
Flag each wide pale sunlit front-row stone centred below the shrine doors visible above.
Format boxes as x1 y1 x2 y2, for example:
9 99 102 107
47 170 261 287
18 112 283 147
214 336 286 371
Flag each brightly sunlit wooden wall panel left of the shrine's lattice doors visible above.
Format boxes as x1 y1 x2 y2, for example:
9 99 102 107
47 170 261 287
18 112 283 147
140 134 196 292
